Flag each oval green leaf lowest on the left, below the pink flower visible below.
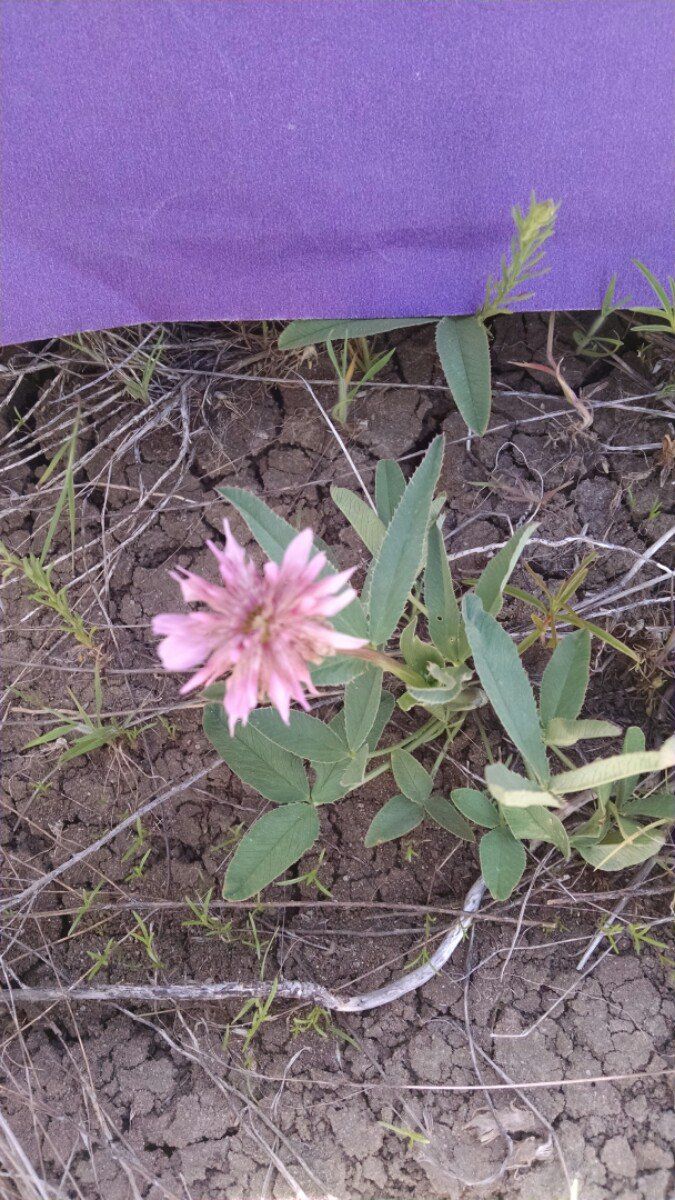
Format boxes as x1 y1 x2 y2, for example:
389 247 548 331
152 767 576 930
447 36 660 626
222 804 318 900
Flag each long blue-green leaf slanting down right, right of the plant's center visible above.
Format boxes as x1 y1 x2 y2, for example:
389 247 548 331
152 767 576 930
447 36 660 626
462 593 549 781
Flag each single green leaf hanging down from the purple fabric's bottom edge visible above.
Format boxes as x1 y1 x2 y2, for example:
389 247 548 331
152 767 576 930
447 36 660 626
436 317 492 434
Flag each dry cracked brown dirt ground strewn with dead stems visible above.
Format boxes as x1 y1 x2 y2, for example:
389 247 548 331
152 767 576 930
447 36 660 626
0 316 675 1200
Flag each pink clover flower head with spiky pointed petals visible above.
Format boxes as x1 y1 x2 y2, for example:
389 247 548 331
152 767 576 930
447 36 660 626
153 521 366 734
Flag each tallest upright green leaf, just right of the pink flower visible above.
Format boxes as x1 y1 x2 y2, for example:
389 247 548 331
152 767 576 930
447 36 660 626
370 437 443 646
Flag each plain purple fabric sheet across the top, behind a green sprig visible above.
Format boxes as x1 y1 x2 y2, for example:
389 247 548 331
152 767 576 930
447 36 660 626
0 0 675 342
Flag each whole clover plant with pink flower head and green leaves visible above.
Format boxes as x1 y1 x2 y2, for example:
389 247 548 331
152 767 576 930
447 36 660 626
156 438 675 907
